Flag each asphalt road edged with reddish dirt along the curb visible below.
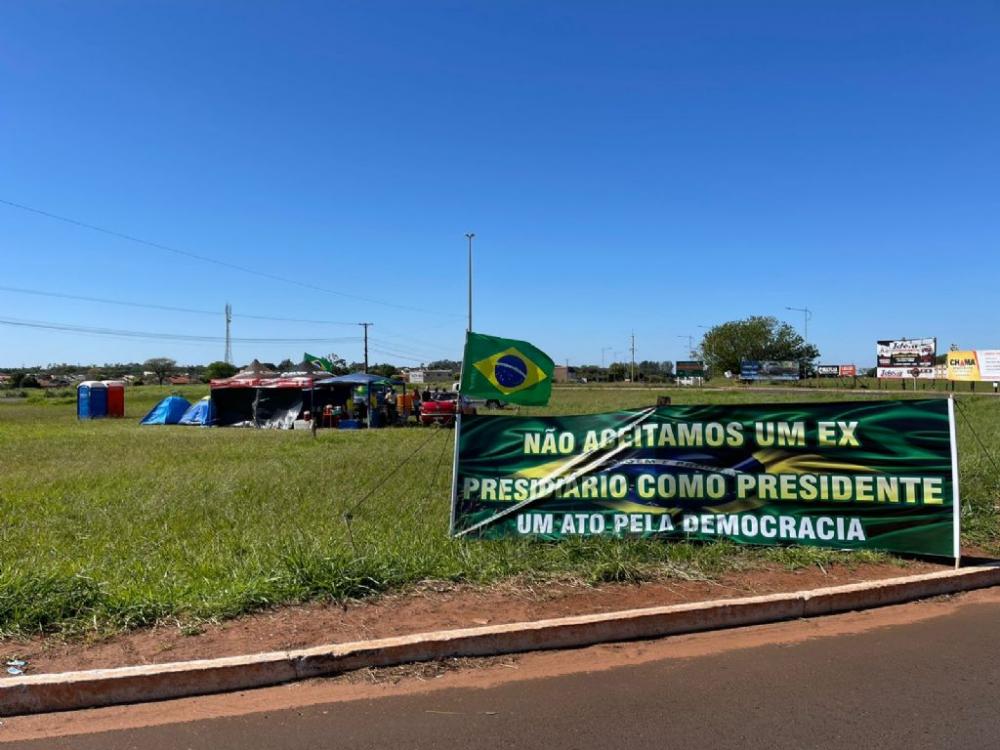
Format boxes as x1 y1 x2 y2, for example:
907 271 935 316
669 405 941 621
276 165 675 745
7 591 1000 750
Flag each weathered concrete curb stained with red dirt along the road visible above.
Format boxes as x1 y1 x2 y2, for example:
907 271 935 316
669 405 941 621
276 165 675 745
0 565 1000 716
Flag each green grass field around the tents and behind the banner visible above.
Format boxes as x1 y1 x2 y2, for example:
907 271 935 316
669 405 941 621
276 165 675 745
0 386 1000 635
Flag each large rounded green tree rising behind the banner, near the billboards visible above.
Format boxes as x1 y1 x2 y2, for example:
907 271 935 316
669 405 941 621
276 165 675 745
701 316 819 375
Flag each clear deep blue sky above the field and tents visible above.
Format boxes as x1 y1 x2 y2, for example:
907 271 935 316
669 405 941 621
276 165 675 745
0 0 1000 366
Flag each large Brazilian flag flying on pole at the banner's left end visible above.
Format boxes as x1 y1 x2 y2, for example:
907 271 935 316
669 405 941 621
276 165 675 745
460 332 555 406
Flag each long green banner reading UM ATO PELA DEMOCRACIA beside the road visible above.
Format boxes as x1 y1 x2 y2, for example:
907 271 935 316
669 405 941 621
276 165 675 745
452 399 958 556
